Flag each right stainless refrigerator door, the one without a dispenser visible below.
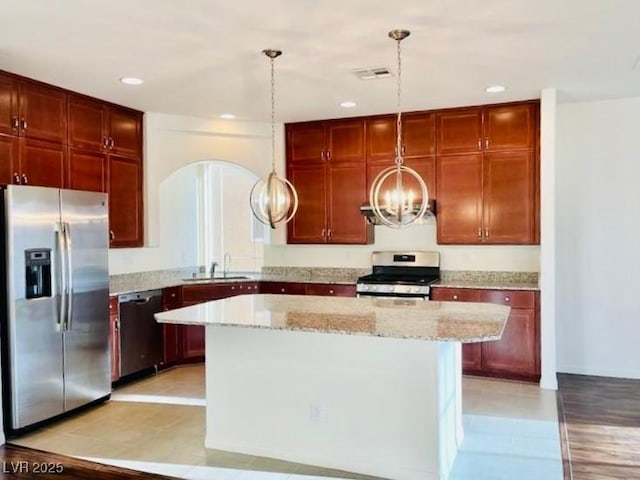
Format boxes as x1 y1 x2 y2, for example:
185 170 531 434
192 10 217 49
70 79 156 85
60 190 111 411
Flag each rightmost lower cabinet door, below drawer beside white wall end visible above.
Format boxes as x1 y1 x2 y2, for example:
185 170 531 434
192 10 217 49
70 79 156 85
482 308 539 376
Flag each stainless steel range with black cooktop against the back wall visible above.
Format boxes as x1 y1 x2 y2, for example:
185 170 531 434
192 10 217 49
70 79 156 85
356 252 440 300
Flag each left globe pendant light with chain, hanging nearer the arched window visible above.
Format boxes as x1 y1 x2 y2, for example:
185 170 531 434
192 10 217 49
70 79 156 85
250 49 298 228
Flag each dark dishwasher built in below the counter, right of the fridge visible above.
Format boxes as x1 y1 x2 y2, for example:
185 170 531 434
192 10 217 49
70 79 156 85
118 290 162 377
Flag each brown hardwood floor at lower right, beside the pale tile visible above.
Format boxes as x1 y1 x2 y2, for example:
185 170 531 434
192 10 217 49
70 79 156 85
558 374 640 480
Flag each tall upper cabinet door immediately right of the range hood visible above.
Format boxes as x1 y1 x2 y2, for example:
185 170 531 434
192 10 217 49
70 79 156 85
436 155 482 244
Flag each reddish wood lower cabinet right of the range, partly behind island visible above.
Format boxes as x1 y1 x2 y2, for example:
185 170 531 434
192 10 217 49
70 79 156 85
431 287 540 381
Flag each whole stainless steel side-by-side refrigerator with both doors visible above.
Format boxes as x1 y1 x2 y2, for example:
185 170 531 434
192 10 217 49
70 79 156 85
0 185 111 431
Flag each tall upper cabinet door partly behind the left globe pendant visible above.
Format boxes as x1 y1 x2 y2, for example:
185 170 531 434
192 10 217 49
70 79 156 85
287 164 327 243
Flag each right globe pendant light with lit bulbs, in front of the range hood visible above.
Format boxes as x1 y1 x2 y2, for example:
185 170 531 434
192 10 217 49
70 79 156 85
369 30 429 228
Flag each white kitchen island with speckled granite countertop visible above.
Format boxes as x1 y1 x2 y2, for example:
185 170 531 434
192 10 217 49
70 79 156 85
156 295 509 480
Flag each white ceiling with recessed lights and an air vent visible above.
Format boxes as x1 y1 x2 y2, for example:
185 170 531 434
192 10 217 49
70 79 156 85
0 0 640 121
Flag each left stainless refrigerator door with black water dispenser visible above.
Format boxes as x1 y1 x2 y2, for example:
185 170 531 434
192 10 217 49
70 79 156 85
3 186 64 429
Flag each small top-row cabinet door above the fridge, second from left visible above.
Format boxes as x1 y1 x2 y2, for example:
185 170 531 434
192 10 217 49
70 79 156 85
18 81 67 144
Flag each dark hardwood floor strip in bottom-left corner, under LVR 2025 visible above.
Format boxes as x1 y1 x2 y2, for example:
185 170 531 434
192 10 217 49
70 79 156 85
0 444 174 480
